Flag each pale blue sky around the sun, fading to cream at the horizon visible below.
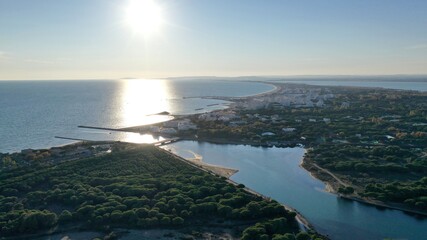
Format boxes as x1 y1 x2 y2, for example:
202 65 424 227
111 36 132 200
0 0 427 80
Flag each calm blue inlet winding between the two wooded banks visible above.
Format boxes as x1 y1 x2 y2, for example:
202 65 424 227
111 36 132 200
166 141 427 240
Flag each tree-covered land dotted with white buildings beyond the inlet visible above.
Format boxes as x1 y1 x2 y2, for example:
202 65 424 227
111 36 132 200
186 85 427 211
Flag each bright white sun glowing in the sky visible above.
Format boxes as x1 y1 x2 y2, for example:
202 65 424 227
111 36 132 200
125 0 163 35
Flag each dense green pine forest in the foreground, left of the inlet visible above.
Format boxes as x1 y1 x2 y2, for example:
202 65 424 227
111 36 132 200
0 144 320 239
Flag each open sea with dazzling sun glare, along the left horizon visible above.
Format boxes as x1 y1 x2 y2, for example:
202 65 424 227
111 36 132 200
0 80 273 152
